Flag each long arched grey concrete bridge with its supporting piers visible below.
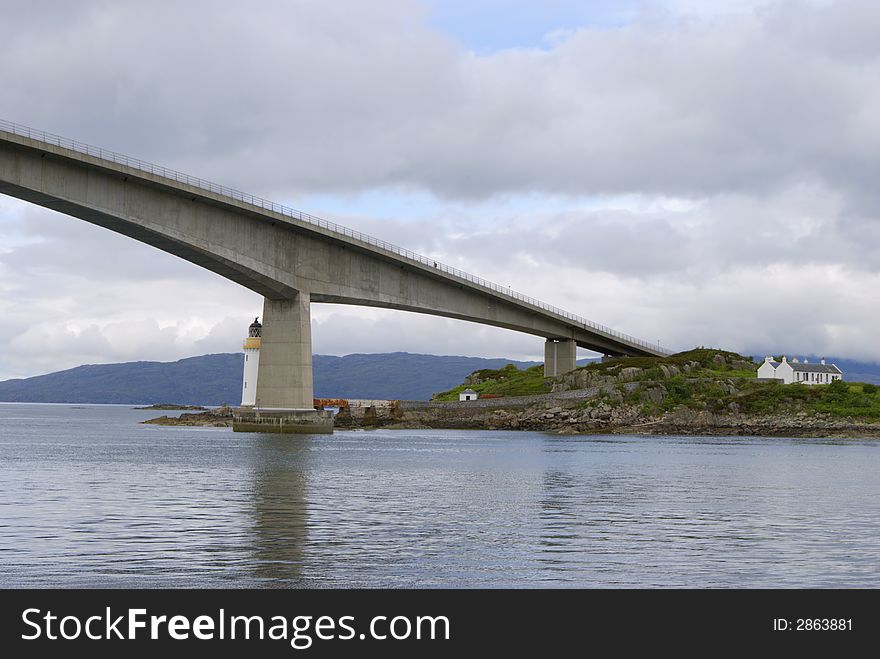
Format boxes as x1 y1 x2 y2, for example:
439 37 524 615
0 121 668 430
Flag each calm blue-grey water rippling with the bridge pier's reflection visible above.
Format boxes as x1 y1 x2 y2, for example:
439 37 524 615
0 404 880 587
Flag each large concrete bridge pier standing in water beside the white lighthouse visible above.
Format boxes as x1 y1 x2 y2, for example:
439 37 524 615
232 291 333 433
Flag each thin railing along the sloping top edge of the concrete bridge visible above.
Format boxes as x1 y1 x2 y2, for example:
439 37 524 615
0 119 671 354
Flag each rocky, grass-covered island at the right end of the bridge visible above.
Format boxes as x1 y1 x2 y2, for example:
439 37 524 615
337 349 880 437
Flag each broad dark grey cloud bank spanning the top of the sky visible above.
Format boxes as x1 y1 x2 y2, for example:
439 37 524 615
0 0 880 204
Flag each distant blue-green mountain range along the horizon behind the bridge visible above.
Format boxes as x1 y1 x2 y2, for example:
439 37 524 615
0 352 880 405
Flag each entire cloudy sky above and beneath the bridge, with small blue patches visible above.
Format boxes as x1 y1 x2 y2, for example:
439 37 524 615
0 0 880 379
